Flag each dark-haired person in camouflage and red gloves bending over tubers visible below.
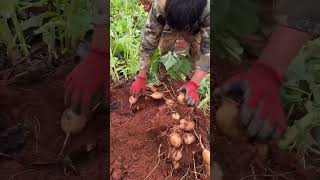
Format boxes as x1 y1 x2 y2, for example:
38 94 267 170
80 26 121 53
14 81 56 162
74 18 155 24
130 0 210 106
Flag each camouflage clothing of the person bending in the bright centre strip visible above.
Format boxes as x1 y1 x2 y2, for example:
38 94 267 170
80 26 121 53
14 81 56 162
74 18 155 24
139 0 210 72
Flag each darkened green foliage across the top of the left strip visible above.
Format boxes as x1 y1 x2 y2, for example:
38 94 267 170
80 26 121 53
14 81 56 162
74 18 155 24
0 0 94 64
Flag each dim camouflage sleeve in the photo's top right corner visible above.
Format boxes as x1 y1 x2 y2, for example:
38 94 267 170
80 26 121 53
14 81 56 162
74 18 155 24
275 0 320 33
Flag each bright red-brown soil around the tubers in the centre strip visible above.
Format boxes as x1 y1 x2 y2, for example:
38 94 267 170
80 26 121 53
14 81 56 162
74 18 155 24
110 83 209 180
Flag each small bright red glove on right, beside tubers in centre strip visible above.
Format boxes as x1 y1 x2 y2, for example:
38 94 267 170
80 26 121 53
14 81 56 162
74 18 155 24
179 81 200 106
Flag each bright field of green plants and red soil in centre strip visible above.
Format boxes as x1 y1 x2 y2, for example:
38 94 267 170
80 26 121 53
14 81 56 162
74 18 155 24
110 0 210 179
